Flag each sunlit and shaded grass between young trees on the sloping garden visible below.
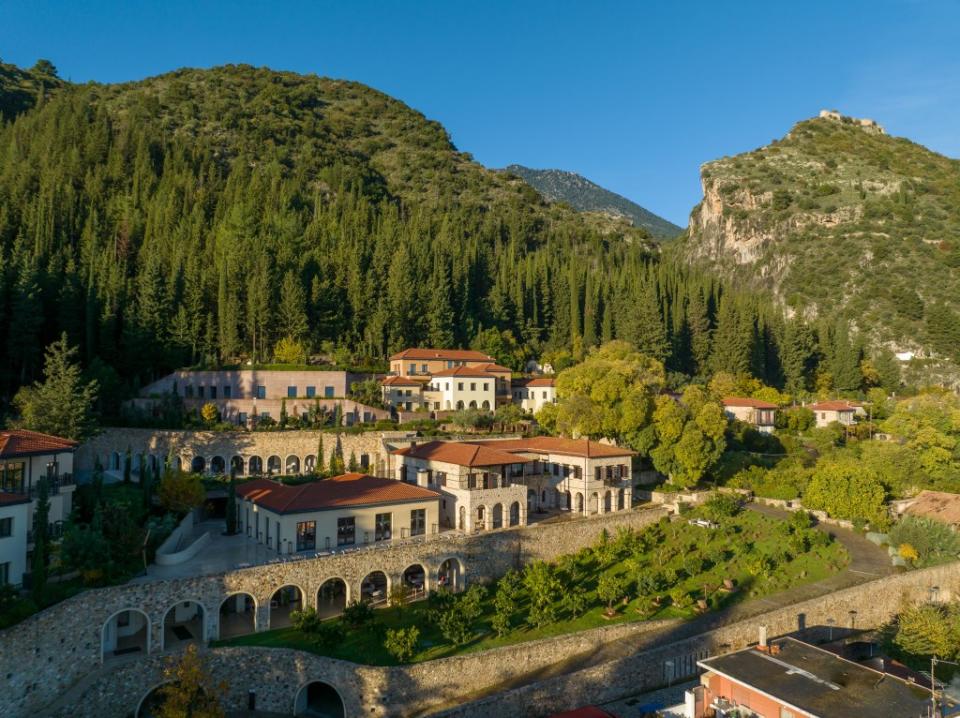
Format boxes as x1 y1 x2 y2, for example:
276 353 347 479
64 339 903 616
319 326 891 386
216 511 849 665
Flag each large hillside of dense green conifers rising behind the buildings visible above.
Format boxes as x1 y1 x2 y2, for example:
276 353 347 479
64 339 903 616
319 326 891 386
0 66 900 420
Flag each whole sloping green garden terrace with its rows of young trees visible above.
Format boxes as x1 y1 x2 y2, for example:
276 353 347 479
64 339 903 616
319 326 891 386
217 507 849 665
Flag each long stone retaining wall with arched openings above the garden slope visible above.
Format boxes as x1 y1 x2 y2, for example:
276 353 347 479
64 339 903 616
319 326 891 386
0 509 665 716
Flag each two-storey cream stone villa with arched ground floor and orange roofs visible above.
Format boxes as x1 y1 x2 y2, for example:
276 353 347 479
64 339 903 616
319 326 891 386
393 436 635 533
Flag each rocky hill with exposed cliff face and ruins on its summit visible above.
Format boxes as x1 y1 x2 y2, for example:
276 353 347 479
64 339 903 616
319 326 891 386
681 112 960 376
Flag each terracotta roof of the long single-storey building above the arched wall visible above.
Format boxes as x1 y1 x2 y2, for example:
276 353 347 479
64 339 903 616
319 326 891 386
237 473 440 514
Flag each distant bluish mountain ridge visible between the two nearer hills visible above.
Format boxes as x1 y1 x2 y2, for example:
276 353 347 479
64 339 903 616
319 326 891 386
504 165 683 239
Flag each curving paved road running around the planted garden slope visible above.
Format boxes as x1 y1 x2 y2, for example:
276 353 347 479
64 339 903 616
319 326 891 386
424 503 893 713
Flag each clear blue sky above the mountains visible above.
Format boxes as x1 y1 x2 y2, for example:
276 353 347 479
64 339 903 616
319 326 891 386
0 0 960 225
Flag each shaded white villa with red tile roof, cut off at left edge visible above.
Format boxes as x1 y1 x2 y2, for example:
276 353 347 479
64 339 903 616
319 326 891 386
0 429 77 586
